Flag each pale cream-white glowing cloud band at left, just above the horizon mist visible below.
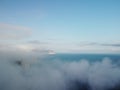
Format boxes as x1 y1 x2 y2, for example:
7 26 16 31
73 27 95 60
0 42 51 55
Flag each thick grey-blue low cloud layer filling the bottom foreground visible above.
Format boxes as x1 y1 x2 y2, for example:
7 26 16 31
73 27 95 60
0 52 120 90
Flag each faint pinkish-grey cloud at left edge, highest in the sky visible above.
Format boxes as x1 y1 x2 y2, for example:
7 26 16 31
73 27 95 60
0 23 32 40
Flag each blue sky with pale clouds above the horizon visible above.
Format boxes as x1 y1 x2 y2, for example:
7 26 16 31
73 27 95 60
0 0 120 53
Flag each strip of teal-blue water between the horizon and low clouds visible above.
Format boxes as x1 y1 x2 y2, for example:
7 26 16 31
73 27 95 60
46 54 120 62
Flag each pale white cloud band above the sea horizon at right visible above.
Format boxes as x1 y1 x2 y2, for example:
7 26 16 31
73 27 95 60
61 42 120 53
